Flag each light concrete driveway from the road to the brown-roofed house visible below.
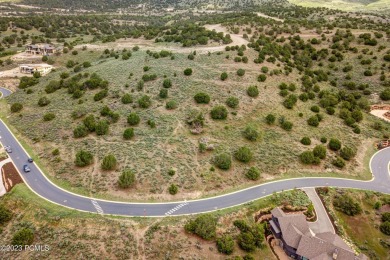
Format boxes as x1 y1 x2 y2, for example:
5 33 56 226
302 188 336 234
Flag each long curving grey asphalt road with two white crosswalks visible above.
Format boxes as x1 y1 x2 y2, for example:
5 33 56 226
0 116 390 217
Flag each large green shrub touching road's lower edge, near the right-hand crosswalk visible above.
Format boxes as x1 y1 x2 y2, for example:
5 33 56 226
184 214 217 240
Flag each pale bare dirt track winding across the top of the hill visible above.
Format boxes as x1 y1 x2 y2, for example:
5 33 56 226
80 24 248 54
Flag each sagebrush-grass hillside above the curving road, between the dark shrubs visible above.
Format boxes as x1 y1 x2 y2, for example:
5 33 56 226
3 22 387 201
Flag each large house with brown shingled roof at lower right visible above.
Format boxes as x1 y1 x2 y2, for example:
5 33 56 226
269 208 368 260
